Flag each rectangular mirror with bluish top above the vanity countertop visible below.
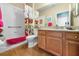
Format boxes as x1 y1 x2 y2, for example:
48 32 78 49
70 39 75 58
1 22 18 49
56 11 71 26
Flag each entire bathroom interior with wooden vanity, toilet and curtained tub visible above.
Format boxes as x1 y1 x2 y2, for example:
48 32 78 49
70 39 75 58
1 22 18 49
0 3 79 56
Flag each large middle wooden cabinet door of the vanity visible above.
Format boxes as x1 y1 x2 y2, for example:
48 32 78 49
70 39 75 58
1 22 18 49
46 37 62 55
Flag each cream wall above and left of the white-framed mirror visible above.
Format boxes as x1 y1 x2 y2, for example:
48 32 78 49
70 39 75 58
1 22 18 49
39 3 69 25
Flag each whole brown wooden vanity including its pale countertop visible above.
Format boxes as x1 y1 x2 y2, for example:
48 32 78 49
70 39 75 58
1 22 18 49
38 28 79 56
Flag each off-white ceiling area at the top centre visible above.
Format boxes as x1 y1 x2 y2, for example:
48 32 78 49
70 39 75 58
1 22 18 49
26 3 55 11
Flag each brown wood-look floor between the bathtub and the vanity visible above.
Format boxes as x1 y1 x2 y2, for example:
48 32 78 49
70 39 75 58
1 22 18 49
0 45 51 56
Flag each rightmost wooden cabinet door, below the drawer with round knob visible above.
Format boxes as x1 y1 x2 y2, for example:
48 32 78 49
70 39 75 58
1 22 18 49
66 40 79 56
